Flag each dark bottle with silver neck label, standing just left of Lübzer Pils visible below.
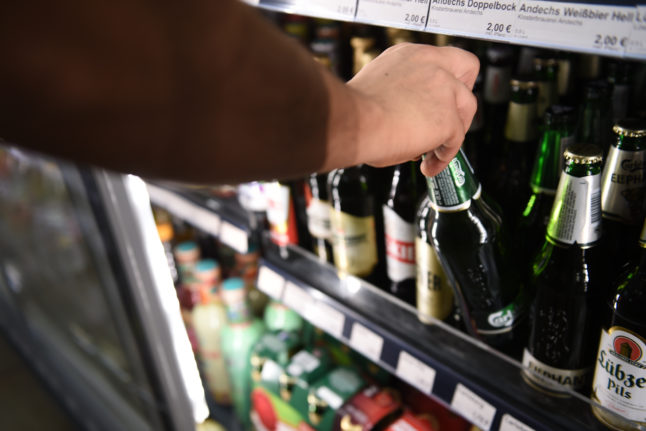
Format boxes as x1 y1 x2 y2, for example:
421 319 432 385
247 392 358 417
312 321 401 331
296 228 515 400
523 144 605 394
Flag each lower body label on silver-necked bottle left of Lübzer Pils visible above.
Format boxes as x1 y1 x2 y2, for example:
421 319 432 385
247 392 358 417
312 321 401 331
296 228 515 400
523 349 592 391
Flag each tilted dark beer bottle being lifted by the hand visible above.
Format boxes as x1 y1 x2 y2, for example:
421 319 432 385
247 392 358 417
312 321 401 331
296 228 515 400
427 150 526 355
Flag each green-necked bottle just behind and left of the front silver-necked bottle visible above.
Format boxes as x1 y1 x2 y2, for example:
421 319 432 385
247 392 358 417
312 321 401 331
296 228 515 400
517 105 576 267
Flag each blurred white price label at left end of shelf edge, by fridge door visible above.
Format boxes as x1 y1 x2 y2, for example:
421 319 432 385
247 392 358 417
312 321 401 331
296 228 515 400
147 184 221 236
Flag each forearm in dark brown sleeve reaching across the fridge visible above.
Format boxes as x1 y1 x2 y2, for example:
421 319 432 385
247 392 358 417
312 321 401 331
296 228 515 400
0 0 357 182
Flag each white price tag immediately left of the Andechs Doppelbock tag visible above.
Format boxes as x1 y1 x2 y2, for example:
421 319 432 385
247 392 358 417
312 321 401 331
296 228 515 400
357 0 430 30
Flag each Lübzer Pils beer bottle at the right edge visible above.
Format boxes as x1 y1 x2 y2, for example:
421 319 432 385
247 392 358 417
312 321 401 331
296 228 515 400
592 220 646 430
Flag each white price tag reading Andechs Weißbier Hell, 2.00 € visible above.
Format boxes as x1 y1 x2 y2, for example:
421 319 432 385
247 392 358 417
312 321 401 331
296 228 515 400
513 0 636 55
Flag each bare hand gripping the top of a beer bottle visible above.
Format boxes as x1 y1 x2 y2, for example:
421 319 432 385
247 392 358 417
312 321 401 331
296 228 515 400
347 43 479 176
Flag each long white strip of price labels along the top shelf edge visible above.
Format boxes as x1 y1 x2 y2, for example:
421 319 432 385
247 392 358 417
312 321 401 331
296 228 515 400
246 0 646 59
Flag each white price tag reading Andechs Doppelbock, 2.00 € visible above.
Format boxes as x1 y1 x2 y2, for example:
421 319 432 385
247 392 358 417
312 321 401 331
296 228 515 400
426 0 522 40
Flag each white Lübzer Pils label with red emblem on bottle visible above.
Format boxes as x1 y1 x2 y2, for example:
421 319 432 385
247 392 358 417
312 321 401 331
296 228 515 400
592 326 646 423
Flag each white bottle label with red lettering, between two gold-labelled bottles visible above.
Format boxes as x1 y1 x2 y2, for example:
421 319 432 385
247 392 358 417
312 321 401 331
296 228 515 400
383 205 415 281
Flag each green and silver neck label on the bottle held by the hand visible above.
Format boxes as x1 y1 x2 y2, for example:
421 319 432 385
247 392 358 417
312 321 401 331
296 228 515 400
426 153 481 212
